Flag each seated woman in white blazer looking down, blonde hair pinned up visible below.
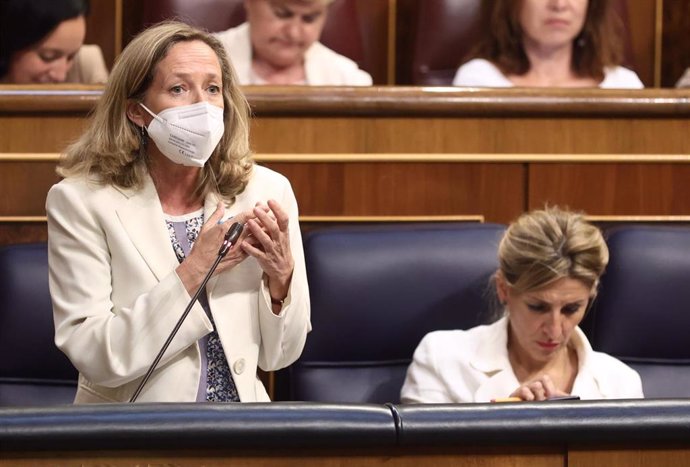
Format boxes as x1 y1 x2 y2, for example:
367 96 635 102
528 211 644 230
401 208 642 403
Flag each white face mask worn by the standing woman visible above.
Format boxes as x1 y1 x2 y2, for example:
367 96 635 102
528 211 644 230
140 102 225 167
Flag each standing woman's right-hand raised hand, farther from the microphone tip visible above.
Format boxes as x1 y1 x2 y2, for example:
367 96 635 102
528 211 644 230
242 200 295 309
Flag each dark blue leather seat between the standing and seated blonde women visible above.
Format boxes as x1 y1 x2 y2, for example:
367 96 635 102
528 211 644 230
276 223 504 403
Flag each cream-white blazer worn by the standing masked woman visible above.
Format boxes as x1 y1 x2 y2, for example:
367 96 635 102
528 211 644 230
46 166 311 403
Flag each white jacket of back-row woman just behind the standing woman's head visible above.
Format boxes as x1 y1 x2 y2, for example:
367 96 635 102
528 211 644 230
214 23 372 86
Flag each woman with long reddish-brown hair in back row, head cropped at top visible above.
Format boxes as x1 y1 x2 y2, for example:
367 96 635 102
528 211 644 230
453 0 644 89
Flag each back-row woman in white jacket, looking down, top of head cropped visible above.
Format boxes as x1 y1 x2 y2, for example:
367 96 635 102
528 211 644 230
216 0 372 86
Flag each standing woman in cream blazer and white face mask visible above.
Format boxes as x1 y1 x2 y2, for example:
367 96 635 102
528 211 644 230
46 22 310 403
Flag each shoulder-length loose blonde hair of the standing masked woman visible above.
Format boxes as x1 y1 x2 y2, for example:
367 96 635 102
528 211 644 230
57 21 253 202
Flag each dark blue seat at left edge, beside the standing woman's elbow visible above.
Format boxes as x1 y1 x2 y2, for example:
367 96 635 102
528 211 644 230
0 243 77 406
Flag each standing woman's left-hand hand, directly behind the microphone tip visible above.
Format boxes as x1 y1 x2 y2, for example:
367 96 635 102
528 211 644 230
177 202 256 296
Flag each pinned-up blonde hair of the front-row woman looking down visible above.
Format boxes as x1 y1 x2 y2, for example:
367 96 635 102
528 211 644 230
498 207 609 295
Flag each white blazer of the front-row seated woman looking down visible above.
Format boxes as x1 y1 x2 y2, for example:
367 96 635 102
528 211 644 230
400 317 643 403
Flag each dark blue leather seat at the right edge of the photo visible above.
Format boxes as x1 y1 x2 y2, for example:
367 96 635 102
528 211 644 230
589 226 690 397
